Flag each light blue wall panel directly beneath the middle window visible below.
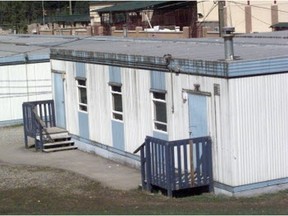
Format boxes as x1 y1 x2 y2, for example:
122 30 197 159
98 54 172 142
112 120 125 151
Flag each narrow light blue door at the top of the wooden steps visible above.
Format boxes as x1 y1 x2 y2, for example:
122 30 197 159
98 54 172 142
54 73 66 128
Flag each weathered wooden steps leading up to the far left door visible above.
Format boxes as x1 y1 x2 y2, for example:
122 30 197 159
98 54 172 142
42 127 77 152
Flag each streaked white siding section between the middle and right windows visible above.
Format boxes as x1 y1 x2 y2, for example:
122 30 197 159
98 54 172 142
121 68 153 153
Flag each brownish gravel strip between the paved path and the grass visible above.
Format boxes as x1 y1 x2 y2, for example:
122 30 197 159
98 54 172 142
0 163 97 196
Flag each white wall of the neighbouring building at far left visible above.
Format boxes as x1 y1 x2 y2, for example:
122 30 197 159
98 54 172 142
0 63 52 121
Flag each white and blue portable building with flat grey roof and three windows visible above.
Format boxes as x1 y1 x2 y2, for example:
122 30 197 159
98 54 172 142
50 31 288 196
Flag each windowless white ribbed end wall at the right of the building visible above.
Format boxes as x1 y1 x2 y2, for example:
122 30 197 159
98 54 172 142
229 74 288 186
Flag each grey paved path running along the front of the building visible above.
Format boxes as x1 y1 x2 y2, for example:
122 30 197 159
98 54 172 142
0 126 141 190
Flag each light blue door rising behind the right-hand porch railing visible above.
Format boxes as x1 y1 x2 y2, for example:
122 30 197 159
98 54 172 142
188 94 209 138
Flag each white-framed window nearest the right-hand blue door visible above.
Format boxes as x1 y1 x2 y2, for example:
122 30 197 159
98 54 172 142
151 91 168 133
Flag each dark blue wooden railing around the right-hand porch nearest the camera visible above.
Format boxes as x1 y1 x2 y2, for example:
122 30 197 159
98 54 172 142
134 137 213 196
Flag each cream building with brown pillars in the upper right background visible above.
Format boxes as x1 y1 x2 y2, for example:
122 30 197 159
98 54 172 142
198 0 288 33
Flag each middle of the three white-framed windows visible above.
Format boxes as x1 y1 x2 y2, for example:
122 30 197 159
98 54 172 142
109 83 124 122
